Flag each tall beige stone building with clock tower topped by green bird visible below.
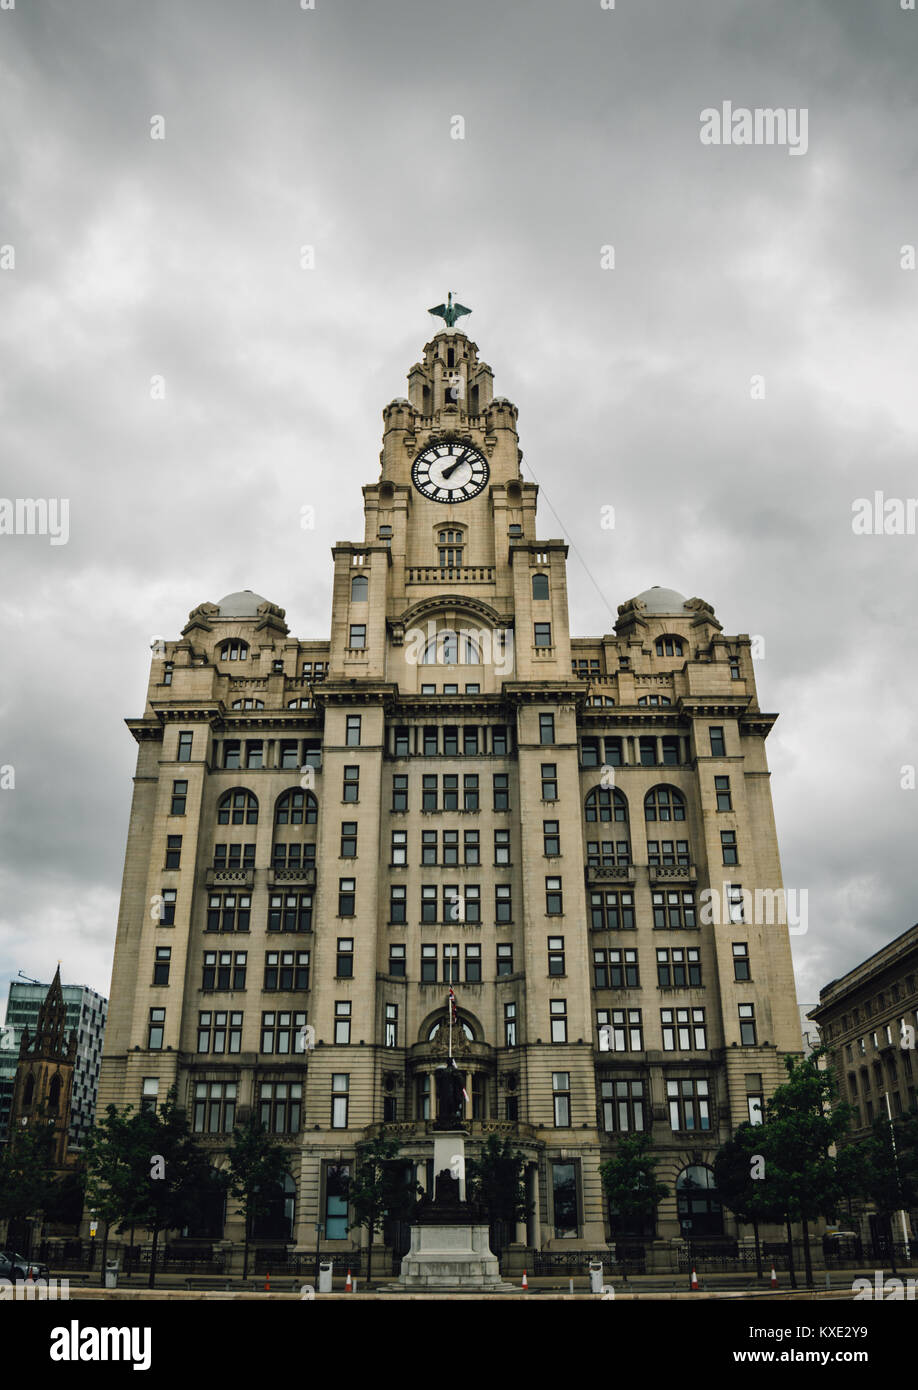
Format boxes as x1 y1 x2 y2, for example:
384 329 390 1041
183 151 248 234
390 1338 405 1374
100 304 800 1252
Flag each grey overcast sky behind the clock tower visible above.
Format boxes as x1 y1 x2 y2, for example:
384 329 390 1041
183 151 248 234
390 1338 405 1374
0 0 918 1023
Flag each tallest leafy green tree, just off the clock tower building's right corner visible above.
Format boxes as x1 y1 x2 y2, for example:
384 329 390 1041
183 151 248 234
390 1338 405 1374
759 1048 854 1289
